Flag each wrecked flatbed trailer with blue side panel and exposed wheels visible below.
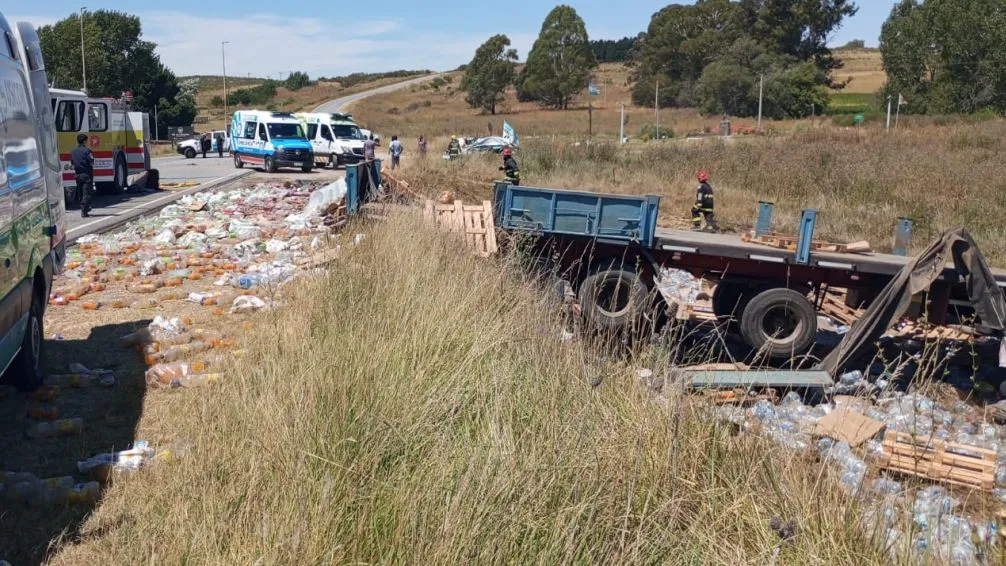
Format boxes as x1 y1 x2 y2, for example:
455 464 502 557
493 182 1006 357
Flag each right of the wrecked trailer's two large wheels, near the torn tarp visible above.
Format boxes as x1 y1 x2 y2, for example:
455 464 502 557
740 289 817 358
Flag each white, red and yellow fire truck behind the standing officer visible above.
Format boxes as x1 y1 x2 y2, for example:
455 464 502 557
49 88 150 203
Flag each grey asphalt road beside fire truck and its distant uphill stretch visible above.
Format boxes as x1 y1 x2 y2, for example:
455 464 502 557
66 74 440 239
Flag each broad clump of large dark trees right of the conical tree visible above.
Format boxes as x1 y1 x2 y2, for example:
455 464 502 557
633 0 856 117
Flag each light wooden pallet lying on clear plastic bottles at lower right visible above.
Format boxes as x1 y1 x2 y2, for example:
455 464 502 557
879 431 996 492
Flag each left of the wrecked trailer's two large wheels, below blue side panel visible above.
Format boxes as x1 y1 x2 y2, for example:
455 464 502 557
578 265 649 330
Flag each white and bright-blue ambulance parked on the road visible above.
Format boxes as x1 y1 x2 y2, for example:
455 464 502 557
230 110 315 173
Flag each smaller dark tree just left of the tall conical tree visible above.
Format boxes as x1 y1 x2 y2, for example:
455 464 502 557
461 34 517 115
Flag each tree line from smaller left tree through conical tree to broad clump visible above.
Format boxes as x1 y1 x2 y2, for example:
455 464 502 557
462 0 857 118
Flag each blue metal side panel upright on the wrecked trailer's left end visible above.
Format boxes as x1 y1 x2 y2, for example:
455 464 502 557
493 181 660 247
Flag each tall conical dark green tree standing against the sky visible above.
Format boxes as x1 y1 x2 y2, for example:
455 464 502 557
517 6 598 109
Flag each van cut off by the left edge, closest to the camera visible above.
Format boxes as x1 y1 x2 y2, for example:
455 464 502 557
0 14 66 389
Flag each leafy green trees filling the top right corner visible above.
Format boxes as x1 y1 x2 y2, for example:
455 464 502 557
880 0 1006 114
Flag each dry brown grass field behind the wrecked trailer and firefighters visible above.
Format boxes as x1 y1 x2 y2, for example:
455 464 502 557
386 121 1006 266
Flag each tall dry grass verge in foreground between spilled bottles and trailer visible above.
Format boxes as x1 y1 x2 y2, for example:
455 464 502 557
53 214 887 565
